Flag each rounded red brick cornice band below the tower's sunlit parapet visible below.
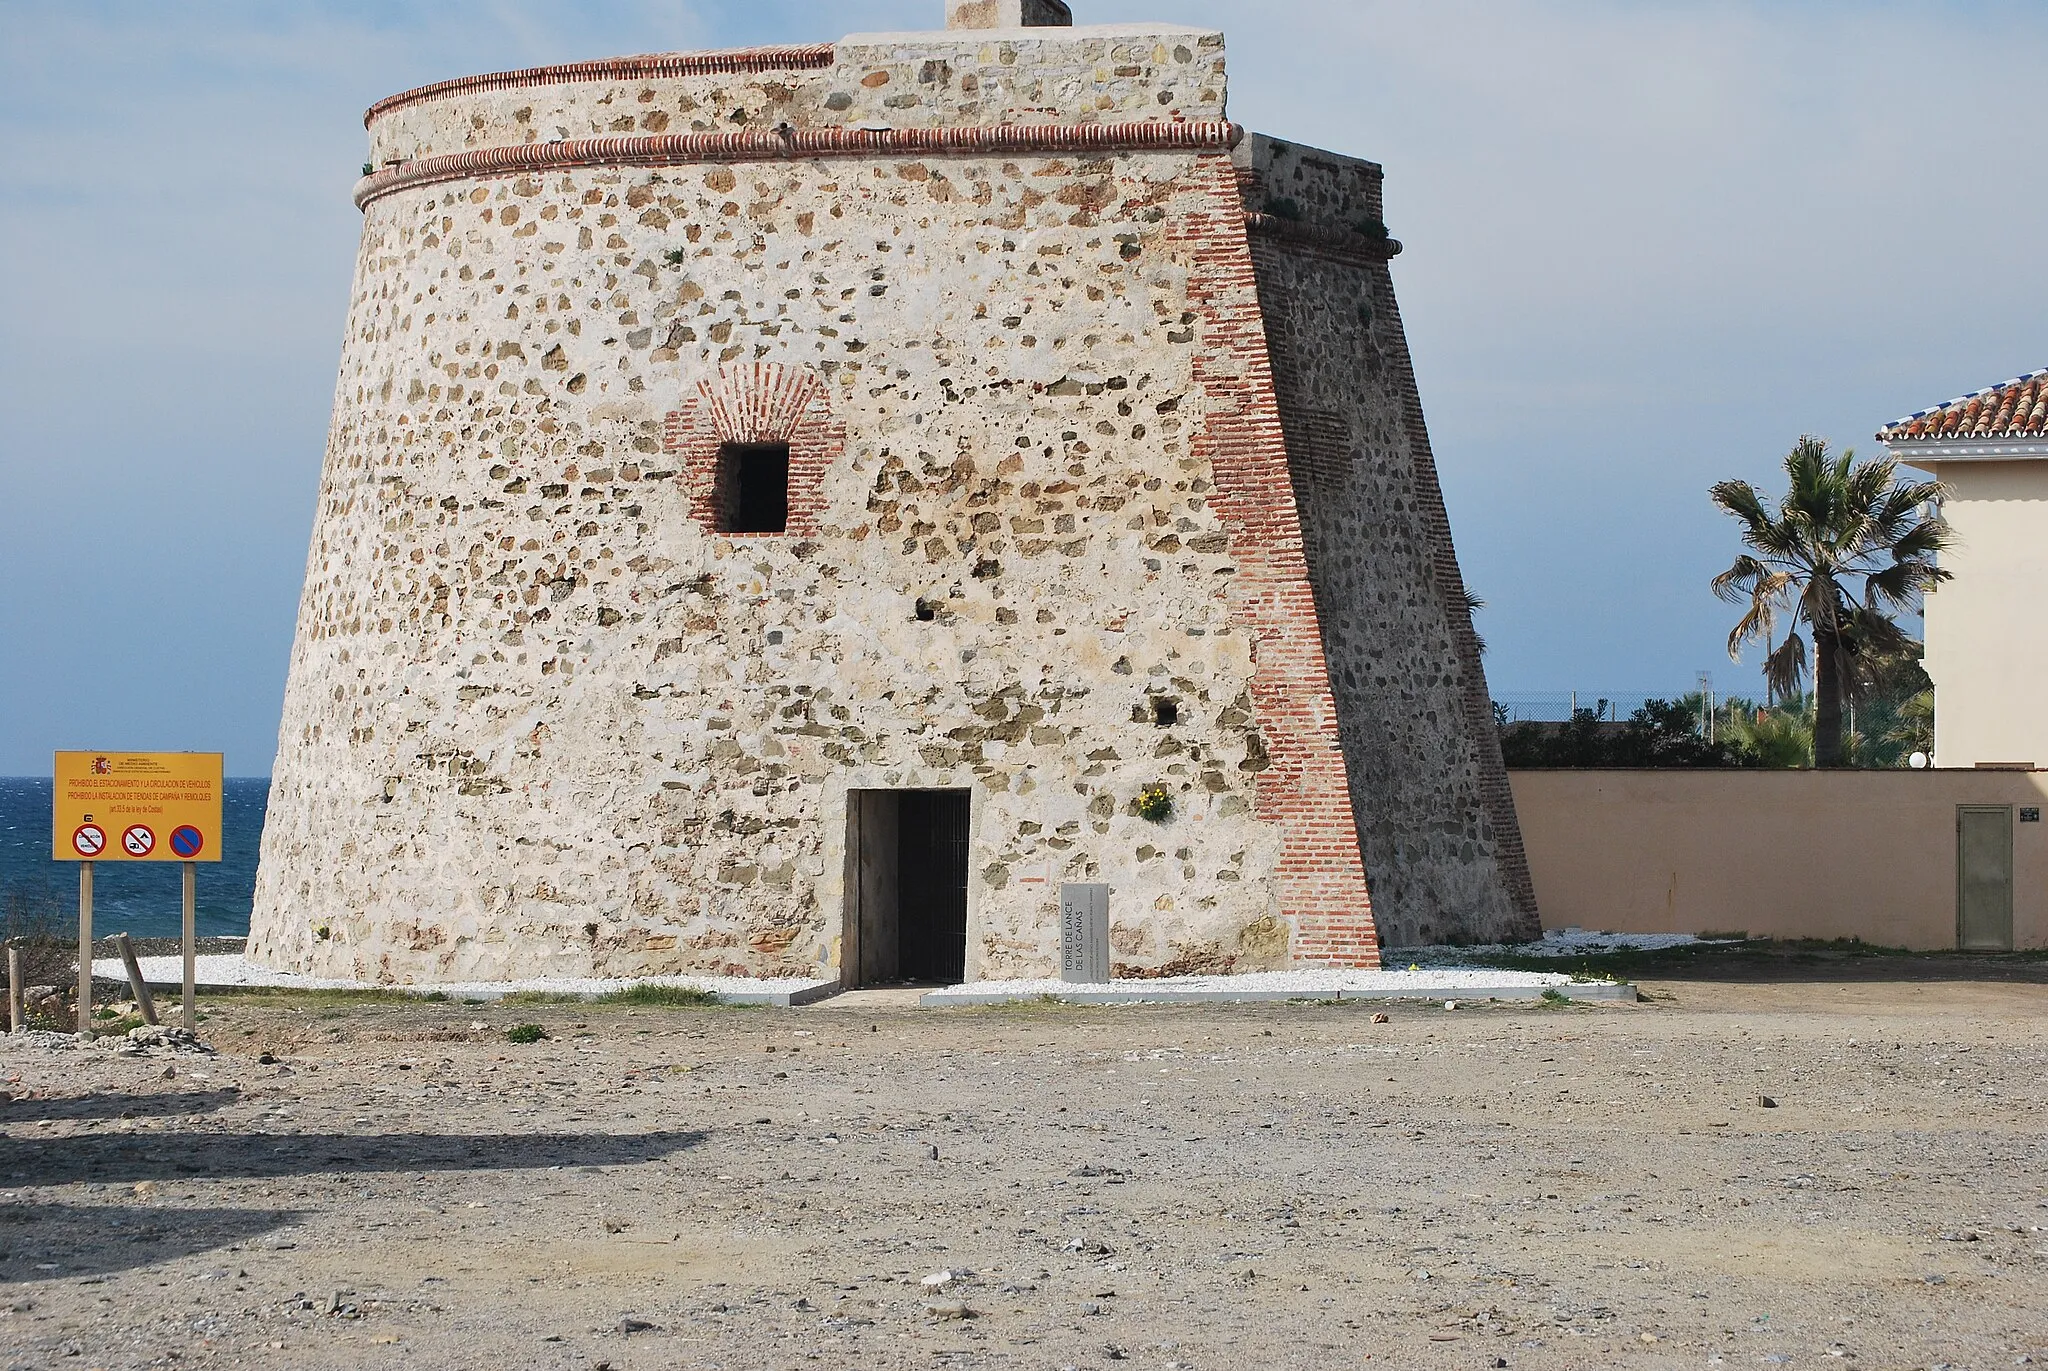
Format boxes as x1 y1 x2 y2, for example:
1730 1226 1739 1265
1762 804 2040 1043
354 119 1245 209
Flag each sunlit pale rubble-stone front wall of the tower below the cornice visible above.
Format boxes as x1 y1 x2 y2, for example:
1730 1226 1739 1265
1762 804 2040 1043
252 31 1364 980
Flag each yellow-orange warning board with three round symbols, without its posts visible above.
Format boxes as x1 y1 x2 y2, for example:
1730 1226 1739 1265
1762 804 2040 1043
51 752 221 861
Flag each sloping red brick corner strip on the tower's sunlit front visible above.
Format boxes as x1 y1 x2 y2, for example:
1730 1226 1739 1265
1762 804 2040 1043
1167 158 1380 967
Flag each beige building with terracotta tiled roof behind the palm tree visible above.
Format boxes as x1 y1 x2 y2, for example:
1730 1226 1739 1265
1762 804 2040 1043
1878 362 2048 766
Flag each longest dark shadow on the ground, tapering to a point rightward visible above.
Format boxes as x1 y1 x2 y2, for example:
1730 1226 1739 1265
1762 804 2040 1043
0 1131 705 1185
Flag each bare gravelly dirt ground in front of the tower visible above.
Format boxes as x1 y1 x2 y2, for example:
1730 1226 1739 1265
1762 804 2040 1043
0 963 2048 1371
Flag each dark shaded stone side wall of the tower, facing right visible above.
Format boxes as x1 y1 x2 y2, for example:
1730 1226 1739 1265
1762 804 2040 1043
1239 137 1540 945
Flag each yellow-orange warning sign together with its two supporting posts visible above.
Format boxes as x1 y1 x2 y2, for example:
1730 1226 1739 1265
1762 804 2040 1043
51 752 221 1033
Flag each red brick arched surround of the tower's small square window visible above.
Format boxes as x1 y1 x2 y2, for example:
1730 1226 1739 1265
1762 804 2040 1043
666 363 846 537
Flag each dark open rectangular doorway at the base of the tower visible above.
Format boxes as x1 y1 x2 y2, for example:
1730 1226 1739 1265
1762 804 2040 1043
840 791 969 988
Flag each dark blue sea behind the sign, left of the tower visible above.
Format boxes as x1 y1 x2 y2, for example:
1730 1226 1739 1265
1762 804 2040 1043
0 777 270 939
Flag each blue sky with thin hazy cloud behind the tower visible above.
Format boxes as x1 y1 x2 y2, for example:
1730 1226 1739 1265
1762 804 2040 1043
0 0 2048 775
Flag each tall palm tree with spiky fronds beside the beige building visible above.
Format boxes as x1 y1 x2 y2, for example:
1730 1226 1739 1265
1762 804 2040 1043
1710 437 1950 766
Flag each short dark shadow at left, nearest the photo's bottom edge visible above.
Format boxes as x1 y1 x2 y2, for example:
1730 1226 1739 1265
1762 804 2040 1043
0 1203 299 1285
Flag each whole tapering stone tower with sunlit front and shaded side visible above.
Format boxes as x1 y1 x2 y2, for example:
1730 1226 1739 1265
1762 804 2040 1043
250 0 1536 984
